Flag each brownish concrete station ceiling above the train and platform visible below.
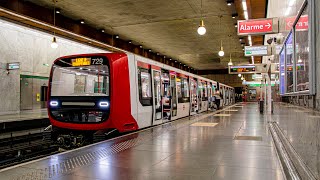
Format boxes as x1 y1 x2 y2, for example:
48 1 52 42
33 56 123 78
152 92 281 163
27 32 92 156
0 0 267 71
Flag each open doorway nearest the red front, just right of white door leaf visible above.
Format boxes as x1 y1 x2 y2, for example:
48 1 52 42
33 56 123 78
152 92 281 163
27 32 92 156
161 69 171 120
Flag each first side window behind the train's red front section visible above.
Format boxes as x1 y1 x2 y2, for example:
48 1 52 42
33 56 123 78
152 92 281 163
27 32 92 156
138 68 152 106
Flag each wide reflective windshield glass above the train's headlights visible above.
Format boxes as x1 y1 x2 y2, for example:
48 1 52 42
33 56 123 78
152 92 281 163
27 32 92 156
51 65 109 96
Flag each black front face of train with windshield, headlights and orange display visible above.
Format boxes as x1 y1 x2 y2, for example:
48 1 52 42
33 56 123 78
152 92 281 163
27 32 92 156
49 56 111 123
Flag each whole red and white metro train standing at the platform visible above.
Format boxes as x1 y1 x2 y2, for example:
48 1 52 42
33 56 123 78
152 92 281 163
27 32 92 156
48 53 234 145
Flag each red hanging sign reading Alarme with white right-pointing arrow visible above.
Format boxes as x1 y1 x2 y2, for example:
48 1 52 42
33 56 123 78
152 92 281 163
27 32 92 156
238 18 278 35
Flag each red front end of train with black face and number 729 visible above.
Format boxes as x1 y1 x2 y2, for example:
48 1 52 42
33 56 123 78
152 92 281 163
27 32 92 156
48 53 137 147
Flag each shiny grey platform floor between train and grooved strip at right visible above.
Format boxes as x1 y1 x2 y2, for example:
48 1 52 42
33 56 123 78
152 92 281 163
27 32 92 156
0 103 285 180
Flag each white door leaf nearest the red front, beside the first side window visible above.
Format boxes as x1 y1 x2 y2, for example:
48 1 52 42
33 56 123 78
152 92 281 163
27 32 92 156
152 69 162 125
